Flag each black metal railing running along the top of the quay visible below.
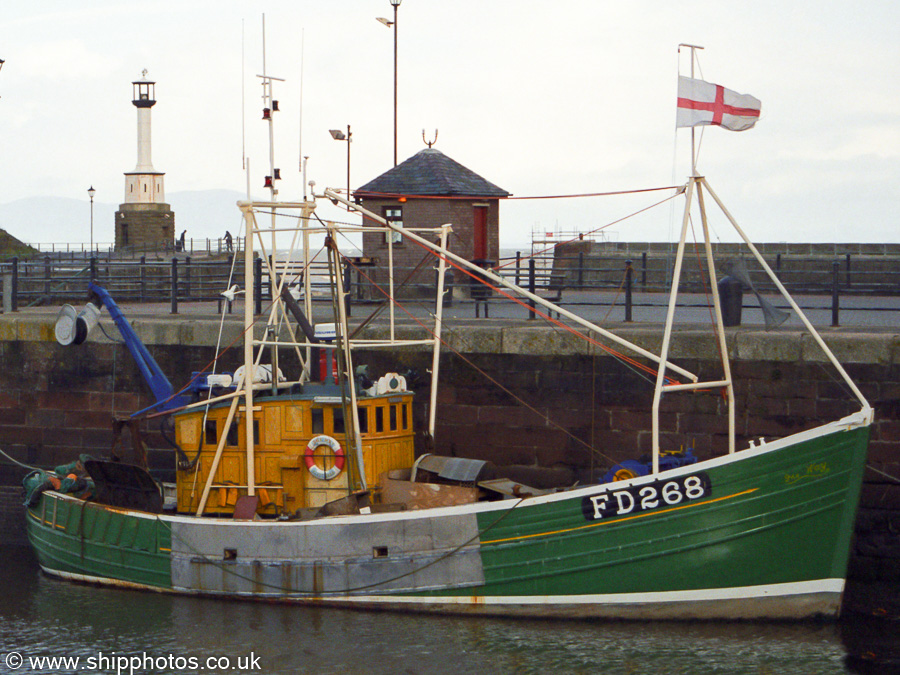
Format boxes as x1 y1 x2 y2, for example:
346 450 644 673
0 254 900 326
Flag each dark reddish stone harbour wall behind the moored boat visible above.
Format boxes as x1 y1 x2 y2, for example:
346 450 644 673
0 316 900 581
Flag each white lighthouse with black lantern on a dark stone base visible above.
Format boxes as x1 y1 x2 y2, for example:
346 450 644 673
116 70 175 250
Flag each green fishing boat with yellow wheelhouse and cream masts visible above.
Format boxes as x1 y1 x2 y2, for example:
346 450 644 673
25 68 873 619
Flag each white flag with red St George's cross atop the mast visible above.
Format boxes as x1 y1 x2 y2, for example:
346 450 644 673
675 76 762 131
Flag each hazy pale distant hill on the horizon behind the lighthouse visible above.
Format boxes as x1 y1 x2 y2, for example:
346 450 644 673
0 190 245 250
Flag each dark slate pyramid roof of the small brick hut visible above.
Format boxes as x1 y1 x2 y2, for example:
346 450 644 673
354 148 511 198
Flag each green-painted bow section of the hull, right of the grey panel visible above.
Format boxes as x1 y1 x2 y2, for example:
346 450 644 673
479 428 868 595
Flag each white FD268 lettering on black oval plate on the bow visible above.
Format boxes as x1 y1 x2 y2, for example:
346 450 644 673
581 472 712 520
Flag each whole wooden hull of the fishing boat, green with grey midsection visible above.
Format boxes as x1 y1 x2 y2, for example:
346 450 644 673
27 419 869 618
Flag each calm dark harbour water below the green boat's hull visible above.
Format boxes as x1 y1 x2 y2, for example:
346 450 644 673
0 547 900 675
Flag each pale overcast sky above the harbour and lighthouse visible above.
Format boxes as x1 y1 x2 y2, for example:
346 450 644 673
0 0 900 244
